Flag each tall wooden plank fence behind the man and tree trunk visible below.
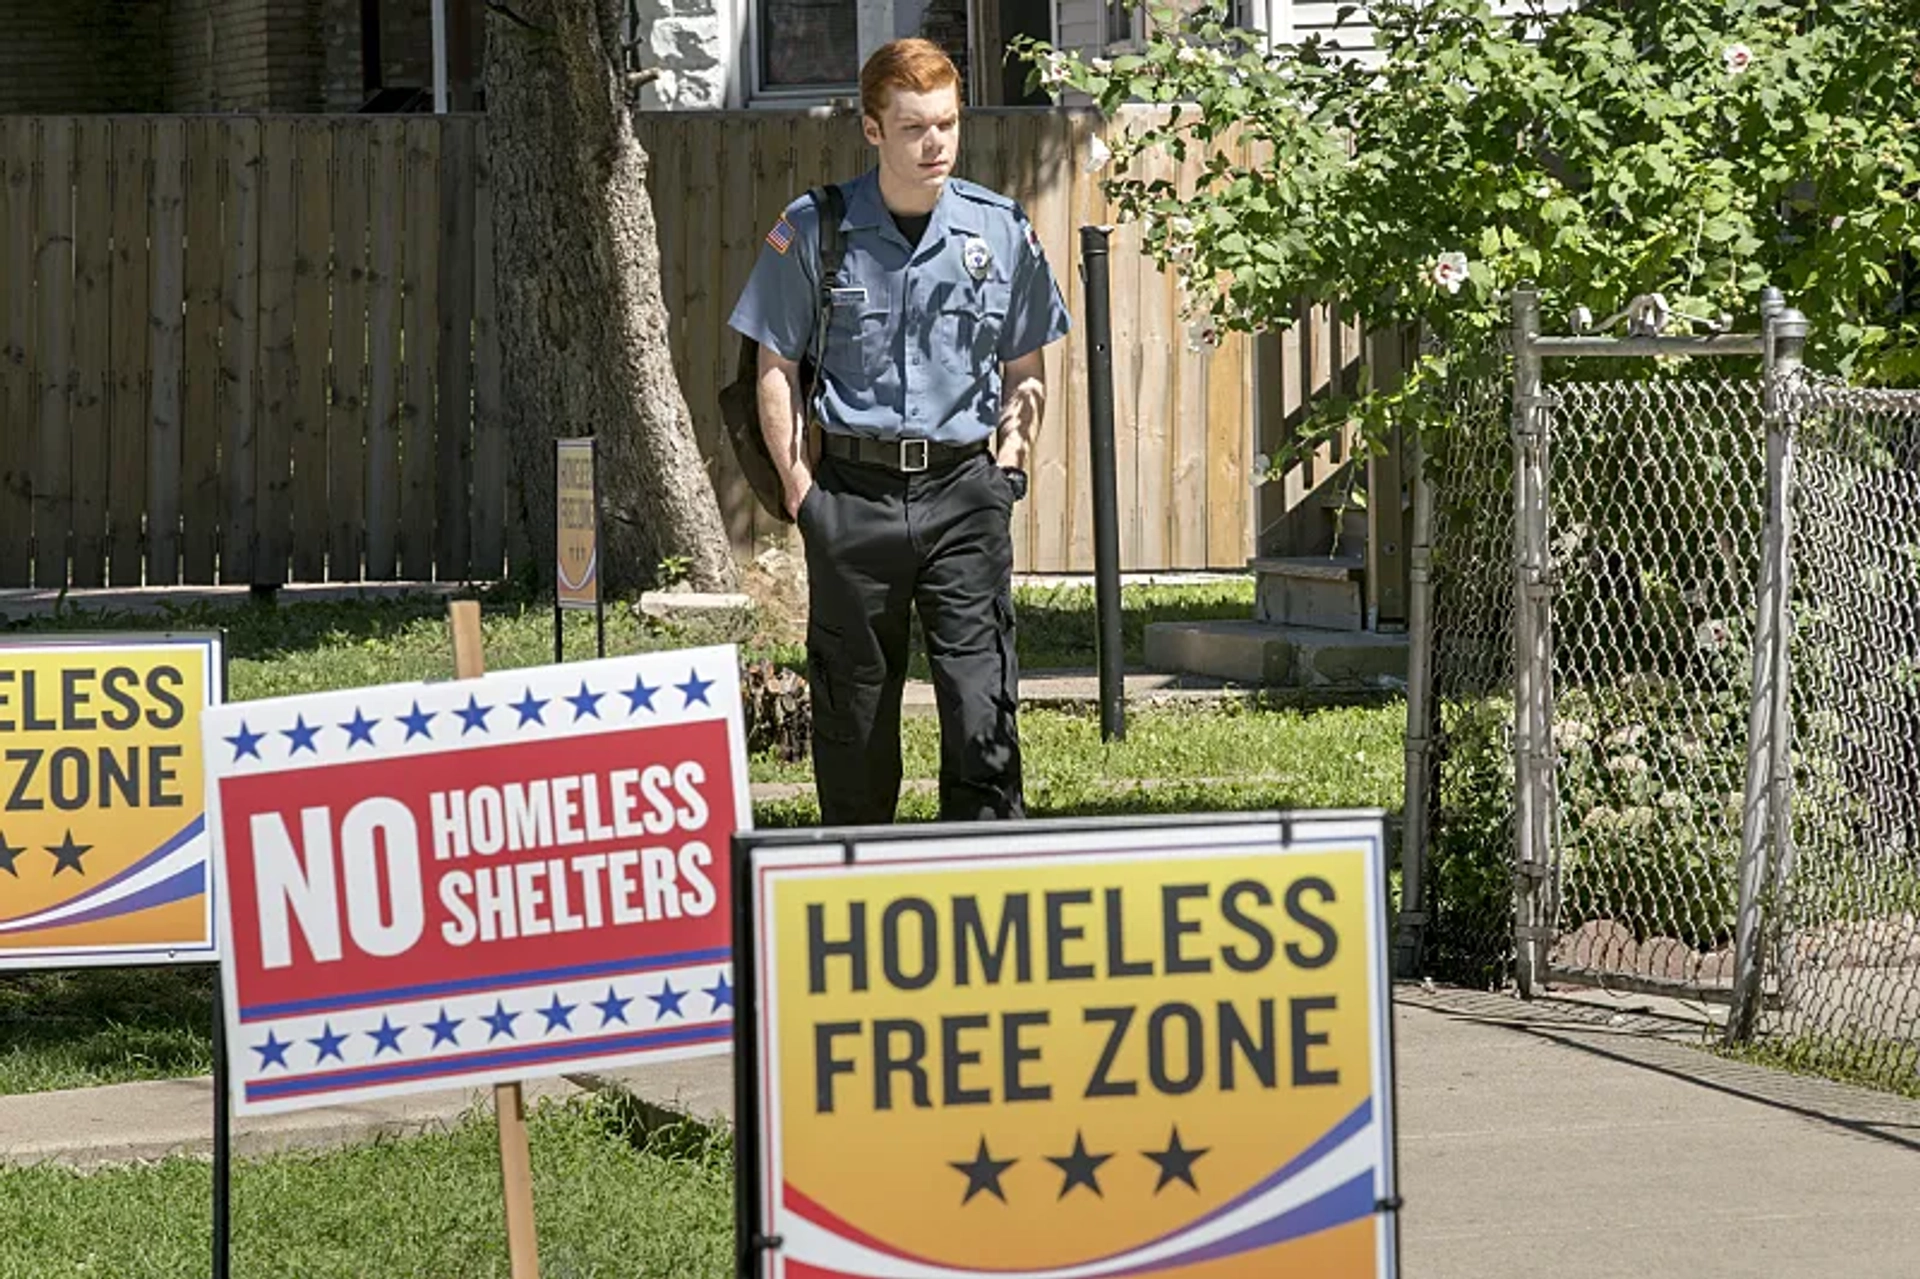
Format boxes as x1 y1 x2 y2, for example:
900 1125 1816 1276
0 109 1382 588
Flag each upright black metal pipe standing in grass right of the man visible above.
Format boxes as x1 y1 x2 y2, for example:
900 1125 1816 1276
1081 227 1127 741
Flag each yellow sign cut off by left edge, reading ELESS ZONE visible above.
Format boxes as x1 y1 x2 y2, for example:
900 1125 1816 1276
0 634 225 968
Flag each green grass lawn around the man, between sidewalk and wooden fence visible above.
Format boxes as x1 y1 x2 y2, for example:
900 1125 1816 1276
0 582 1405 1083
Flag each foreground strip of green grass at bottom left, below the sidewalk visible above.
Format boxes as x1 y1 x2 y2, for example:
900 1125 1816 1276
0 1097 733 1279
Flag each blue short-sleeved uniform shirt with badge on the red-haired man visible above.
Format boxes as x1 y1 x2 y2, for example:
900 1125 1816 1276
728 169 1069 444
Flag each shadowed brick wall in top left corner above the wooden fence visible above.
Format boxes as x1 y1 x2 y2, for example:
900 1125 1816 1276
0 0 167 115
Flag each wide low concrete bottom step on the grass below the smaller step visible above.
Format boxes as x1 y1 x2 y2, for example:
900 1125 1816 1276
1146 620 1407 693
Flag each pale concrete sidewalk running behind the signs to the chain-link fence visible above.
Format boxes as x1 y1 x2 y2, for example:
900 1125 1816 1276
0 985 1920 1279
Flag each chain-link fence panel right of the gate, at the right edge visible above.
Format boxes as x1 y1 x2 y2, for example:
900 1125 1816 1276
1759 374 1920 1087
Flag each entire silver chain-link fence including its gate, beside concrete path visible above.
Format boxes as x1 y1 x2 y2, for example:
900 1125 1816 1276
1402 295 1920 1087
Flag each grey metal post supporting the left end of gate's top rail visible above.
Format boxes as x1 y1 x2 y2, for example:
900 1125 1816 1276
1513 280 1549 999
